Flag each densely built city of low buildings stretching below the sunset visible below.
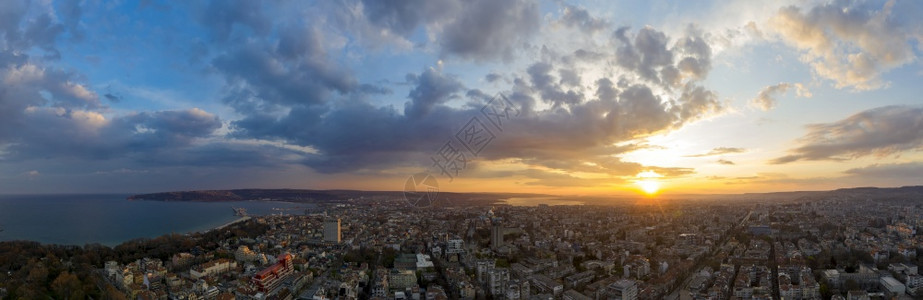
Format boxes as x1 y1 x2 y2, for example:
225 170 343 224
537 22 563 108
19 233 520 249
97 197 923 300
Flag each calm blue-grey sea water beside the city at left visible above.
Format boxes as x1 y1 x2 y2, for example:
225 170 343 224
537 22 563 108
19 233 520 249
0 195 313 246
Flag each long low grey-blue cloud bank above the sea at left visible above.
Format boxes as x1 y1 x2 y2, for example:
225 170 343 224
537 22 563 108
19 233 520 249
7 108 222 160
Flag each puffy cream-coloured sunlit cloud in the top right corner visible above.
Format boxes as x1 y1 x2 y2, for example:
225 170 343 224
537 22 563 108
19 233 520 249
769 1 923 90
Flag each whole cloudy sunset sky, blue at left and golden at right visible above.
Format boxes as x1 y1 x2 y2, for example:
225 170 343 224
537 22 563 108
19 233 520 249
0 0 923 195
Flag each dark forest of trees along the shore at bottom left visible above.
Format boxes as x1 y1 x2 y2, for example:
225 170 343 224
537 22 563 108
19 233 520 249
0 220 268 299
